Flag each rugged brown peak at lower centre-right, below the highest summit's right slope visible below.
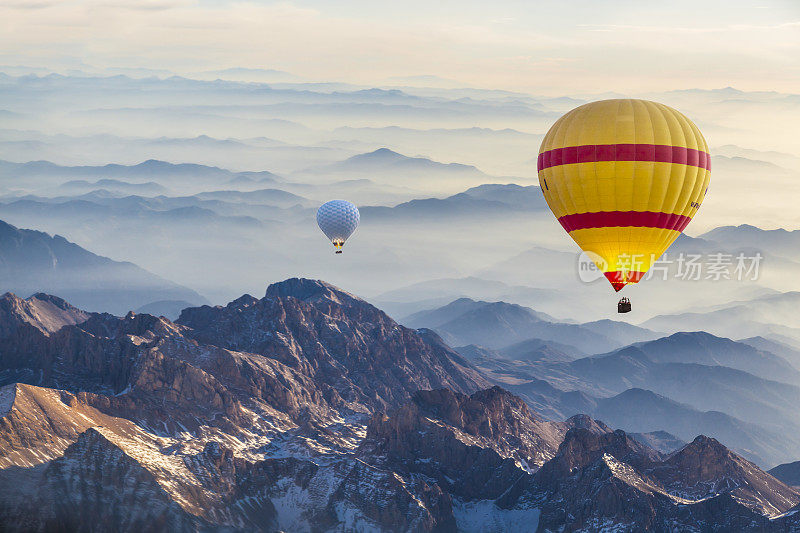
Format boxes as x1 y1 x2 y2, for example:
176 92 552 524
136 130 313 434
360 387 565 498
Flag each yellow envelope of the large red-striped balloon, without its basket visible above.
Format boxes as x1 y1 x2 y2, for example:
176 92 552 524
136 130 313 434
538 99 711 291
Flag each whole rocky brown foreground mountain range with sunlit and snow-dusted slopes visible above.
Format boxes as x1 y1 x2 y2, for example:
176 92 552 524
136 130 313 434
0 278 800 531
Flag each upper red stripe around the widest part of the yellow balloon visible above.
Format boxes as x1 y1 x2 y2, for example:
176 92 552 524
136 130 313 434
538 144 711 170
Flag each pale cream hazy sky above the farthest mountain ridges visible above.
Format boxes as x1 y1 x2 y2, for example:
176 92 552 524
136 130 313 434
0 0 800 94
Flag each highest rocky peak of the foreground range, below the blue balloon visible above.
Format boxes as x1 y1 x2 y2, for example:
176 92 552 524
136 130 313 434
177 278 488 412
